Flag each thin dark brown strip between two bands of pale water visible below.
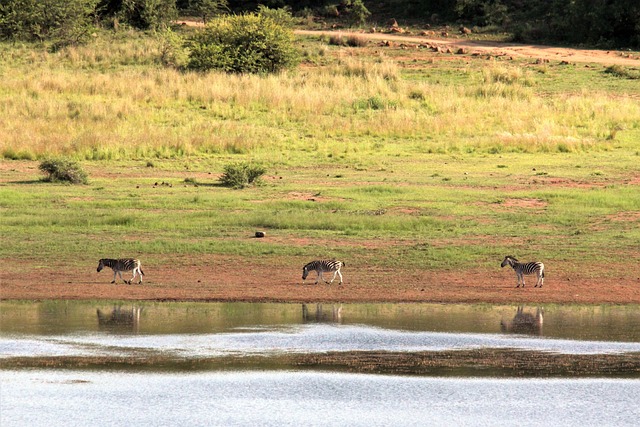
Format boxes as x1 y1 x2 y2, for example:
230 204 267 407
5 349 640 378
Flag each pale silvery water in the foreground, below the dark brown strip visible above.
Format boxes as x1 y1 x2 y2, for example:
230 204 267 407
0 370 640 427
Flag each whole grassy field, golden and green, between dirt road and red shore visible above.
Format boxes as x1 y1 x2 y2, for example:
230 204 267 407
0 26 640 288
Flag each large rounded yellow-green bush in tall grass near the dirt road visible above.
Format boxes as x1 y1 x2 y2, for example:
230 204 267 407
188 14 298 74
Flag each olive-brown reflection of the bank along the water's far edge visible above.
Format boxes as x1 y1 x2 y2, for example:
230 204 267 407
0 300 640 342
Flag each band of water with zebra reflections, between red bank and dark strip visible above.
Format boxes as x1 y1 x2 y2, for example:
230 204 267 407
0 302 640 358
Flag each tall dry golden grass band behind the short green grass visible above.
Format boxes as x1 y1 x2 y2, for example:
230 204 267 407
0 37 640 159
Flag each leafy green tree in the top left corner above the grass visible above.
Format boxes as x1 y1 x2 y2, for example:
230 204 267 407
0 0 98 46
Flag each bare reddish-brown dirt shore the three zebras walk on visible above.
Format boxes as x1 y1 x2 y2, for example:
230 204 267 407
0 255 640 304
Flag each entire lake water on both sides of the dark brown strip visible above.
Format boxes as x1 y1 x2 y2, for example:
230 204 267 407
0 301 640 426
